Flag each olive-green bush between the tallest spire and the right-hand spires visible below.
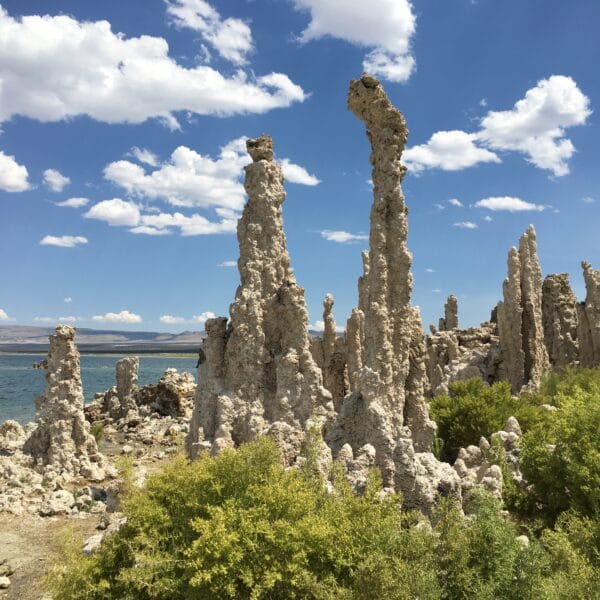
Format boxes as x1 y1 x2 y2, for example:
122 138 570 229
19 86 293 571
430 378 546 463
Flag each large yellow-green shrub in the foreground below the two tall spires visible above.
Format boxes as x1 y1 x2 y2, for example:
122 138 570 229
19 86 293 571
49 438 440 600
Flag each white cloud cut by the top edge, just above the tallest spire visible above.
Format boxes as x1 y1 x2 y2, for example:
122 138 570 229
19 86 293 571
294 0 416 81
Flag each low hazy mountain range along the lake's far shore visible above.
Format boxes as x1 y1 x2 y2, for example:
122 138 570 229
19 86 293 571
0 325 205 353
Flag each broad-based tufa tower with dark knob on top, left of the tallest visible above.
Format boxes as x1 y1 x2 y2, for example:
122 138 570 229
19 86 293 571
187 136 333 459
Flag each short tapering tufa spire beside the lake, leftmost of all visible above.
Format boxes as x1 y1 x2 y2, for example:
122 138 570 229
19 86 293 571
23 325 104 481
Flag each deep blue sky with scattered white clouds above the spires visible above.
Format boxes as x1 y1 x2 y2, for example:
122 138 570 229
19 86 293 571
0 0 600 332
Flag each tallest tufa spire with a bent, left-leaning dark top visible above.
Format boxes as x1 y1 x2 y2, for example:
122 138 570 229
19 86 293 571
328 75 460 512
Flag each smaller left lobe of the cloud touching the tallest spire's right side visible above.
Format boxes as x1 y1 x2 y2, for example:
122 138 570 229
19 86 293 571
402 130 500 173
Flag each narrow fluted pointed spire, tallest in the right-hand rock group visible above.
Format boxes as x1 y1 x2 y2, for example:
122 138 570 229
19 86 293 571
498 225 549 393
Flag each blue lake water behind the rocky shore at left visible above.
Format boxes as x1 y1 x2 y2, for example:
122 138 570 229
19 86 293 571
0 354 197 423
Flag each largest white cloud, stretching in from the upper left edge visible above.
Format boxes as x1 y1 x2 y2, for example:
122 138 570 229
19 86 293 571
0 7 306 128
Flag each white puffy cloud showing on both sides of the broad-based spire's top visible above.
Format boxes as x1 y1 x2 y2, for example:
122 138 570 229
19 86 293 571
104 136 319 210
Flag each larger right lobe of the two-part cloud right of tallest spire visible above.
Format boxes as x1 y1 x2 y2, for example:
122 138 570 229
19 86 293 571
477 75 591 176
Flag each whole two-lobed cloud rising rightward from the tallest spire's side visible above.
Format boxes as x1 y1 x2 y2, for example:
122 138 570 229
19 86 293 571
403 75 591 177
